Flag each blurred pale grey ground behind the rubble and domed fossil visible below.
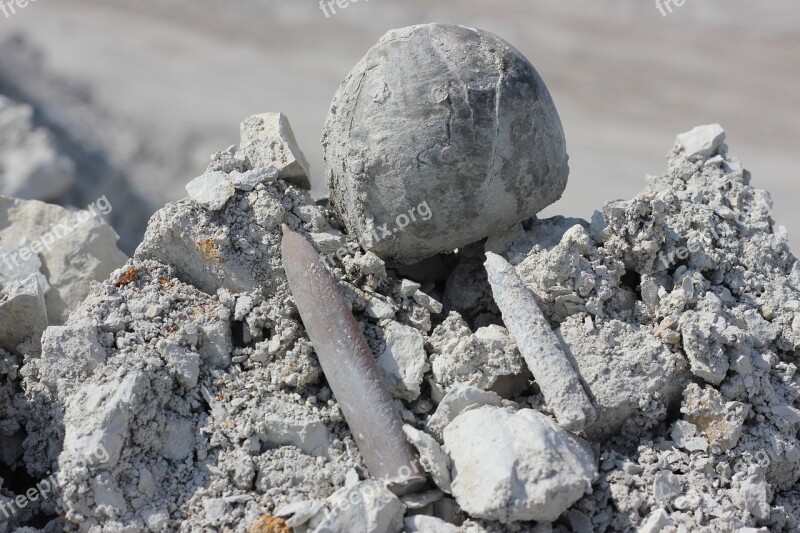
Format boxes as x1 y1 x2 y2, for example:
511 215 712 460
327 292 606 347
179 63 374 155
0 0 800 252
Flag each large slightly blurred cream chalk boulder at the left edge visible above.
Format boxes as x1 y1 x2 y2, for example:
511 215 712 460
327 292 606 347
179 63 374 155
0 196 128 324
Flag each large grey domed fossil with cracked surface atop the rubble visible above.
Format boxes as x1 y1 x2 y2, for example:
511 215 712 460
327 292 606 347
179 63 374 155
322 24 569 263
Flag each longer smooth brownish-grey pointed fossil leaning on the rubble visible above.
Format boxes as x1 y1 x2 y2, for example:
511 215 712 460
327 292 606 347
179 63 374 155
281 225 424 492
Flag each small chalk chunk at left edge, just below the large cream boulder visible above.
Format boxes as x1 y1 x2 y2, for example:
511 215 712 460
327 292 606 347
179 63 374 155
0 275 47 352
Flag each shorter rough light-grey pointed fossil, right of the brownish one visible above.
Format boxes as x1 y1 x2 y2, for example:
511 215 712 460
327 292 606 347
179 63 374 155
484 252 595 431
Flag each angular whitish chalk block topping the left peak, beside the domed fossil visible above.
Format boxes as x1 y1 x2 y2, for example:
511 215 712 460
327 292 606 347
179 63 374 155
240 113 311 189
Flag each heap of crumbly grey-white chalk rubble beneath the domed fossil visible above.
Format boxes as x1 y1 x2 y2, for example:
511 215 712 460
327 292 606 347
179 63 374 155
0 115 800 533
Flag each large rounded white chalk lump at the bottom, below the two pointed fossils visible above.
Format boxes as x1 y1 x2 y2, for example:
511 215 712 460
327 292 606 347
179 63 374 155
444 407 598 524
